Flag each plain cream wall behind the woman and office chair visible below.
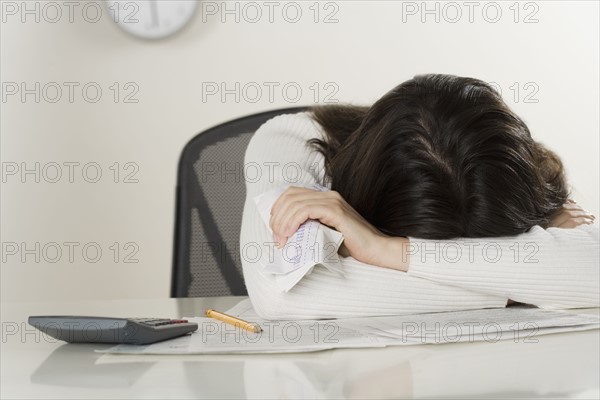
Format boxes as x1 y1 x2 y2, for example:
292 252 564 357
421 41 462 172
1 1 600 301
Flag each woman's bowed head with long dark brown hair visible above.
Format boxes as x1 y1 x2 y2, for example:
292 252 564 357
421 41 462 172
312 75 568 239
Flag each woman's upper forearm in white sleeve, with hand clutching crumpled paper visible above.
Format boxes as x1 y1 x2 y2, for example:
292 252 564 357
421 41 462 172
270 181 600 308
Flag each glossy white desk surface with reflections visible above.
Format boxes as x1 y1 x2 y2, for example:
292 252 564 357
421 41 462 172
1 297 600 398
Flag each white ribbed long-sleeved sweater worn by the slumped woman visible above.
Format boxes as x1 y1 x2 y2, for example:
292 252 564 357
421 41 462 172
240 113 600 319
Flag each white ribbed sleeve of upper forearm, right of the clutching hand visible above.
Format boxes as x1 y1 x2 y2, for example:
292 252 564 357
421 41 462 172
404 225 600 309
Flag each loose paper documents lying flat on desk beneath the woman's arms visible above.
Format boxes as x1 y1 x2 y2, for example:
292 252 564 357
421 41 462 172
99 299 600 354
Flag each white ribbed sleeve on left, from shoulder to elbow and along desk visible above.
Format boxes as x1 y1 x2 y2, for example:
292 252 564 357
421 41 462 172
240 113 507 319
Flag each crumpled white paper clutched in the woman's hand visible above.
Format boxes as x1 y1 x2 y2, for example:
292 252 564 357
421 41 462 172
254 185 344 292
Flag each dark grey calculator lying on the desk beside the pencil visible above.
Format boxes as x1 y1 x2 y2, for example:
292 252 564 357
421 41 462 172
28 315 198 344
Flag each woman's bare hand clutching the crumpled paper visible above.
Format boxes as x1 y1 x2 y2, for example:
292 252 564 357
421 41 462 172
269 186 408 271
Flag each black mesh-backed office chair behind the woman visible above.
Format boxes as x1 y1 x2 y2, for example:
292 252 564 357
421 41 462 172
171 107 308 297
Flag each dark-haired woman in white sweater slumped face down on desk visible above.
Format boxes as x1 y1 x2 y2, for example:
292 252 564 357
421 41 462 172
240 75 600 318
